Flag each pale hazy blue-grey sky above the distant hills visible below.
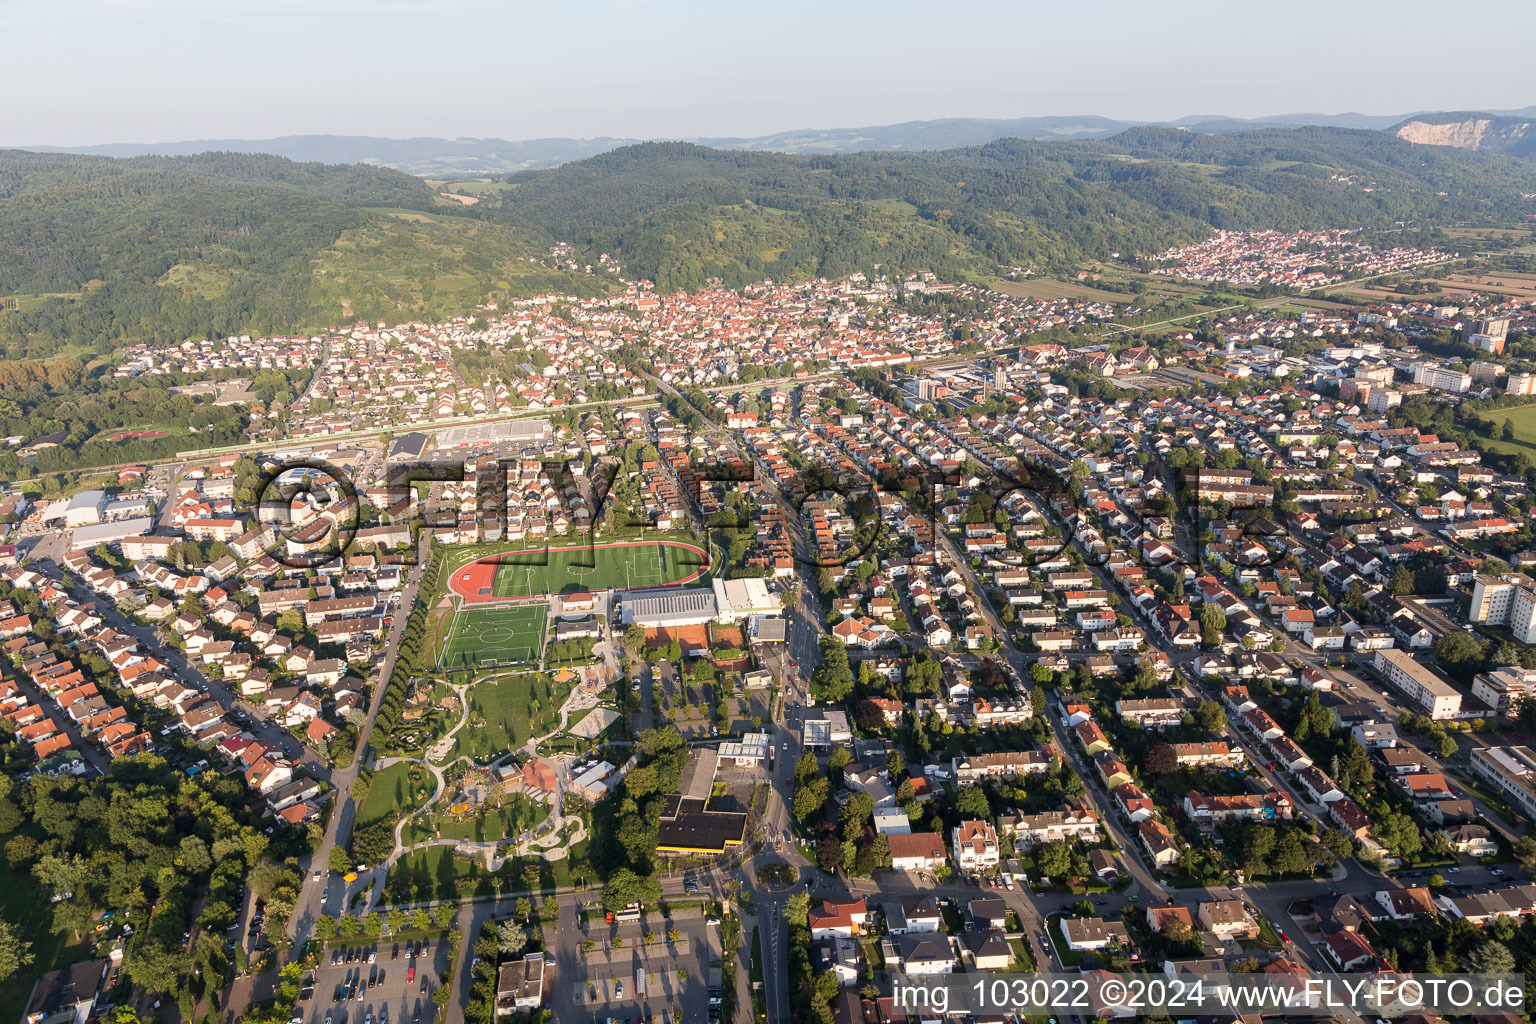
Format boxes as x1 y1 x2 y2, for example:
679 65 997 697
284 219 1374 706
0 0 1536 146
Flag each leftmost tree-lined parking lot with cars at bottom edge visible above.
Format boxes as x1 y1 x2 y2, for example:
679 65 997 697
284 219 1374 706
300 940 449 1024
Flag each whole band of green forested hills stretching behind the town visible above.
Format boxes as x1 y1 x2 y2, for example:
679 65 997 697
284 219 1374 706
0 127 1536 359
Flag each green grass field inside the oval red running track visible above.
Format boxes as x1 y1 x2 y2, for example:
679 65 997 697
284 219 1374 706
492 542 703 599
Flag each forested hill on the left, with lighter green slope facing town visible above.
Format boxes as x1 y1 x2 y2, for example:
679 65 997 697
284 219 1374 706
0 150 602 358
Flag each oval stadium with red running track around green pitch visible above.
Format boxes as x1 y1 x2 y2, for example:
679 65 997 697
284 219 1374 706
449 540 710 605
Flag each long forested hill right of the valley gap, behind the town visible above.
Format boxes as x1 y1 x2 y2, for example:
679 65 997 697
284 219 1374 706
493 127 1536 289
